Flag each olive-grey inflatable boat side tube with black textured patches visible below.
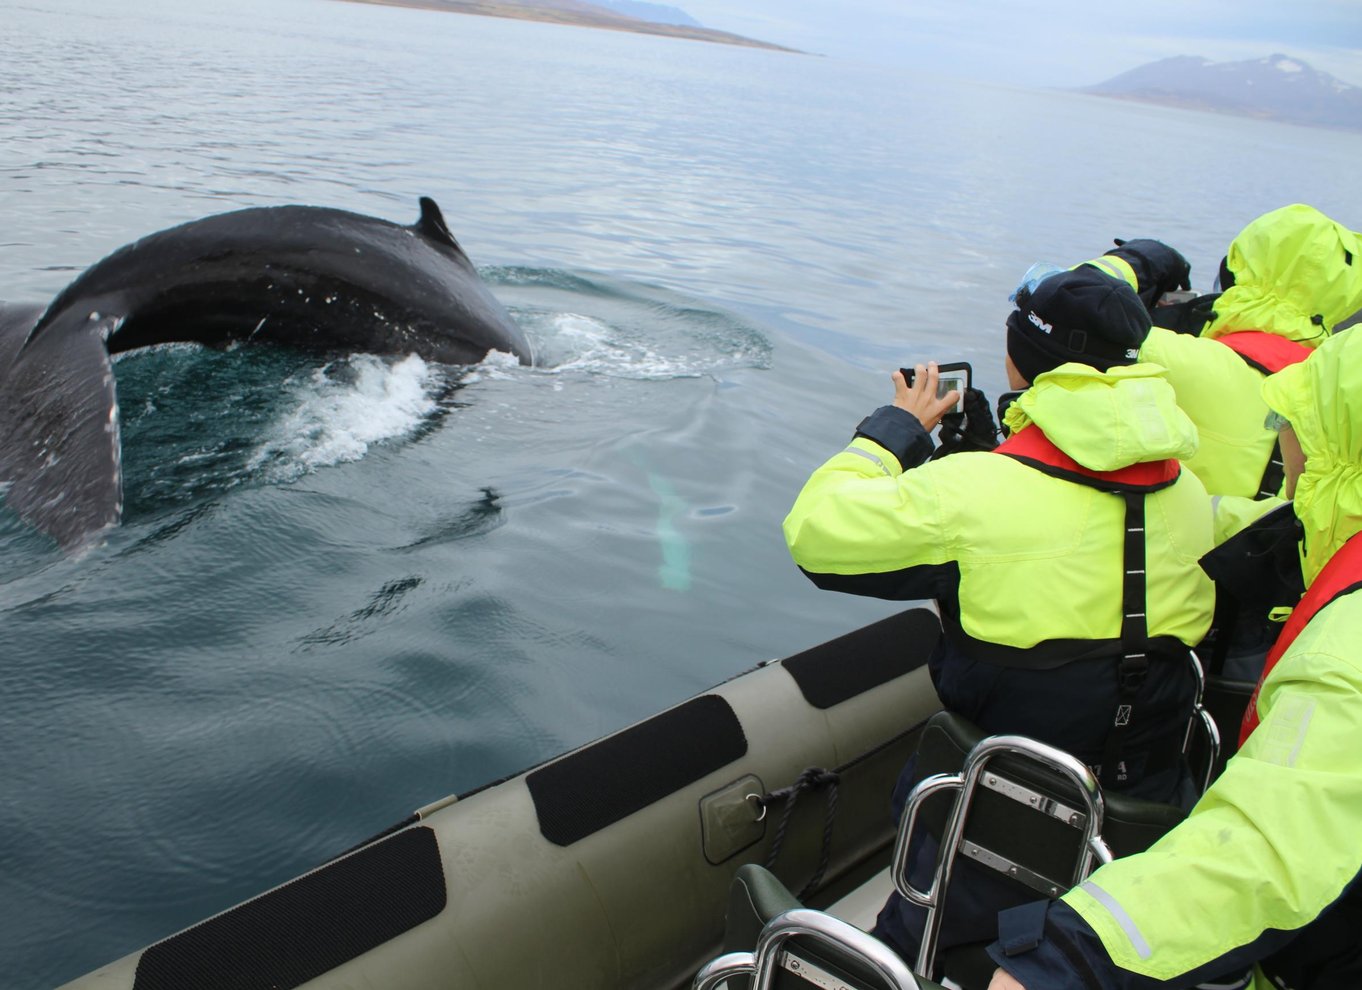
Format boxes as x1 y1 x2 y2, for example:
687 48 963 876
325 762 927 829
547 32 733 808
55 607 1244 990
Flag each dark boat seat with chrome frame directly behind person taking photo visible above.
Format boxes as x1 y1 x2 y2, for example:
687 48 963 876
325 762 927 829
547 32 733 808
891 711 1186 990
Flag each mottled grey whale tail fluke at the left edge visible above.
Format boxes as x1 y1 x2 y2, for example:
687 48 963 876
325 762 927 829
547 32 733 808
0 315 123 554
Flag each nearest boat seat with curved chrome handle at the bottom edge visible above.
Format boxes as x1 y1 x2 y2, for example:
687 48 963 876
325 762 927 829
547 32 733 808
692 863 941 990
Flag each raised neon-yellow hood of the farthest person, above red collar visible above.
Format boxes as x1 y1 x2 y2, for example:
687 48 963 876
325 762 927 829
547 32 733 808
1201 203 1362 347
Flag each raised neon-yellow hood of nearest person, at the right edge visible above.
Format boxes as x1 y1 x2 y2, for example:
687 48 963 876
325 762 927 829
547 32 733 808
1263 331 1362 584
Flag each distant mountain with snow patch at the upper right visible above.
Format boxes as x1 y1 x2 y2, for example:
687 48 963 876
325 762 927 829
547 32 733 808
1083 54 1362 131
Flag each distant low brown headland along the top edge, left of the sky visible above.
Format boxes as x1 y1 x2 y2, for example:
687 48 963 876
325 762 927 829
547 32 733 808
336 0 802 54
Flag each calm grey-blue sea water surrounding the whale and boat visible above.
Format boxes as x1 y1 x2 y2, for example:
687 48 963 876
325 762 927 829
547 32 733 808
0 0 1362 990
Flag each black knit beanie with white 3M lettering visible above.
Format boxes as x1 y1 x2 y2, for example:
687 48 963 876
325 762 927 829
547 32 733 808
1008 266 1150 381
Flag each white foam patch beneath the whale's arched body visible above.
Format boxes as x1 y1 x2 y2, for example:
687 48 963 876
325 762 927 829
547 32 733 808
249 354 439 481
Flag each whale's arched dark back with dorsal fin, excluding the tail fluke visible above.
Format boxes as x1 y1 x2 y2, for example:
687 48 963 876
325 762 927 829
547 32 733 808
34 200 531 364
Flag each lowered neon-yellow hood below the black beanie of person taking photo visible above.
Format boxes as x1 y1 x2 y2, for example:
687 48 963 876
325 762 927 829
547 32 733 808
1004 364 1197 471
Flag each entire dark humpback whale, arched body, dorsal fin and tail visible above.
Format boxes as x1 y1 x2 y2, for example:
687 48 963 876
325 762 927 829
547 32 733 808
0 197 534 554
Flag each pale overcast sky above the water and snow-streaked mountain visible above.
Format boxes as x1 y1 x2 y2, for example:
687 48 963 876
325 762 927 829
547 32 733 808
678 0 1362 86
